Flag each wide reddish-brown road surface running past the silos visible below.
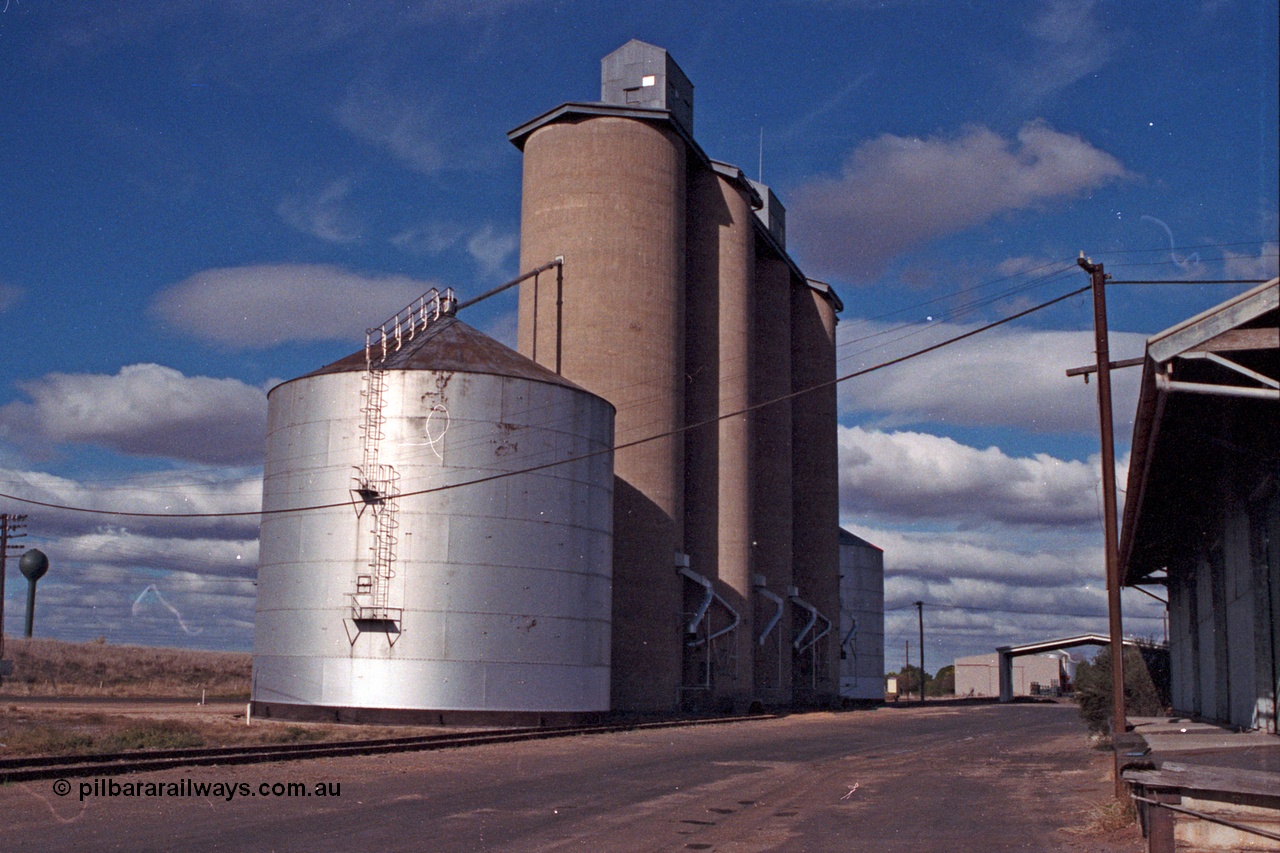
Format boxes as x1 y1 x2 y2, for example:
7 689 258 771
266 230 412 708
0 704 1143 853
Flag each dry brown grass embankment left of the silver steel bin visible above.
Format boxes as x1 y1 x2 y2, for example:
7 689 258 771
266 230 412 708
0 638 252 699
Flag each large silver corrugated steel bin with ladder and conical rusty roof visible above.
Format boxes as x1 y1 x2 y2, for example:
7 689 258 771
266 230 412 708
252 298 613 722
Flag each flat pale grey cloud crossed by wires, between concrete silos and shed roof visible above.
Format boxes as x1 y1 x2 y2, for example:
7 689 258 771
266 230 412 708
837 318 1146 441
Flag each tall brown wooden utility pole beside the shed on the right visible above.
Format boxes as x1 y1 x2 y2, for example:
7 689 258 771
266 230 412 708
1076 252 1128 799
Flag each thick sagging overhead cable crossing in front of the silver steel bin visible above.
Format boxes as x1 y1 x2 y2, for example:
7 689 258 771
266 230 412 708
0 286 1089 519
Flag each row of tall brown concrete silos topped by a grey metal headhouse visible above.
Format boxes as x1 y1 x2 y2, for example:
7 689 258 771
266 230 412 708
509 41 841 711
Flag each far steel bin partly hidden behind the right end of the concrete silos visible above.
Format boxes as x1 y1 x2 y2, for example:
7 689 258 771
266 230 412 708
840 529 884 702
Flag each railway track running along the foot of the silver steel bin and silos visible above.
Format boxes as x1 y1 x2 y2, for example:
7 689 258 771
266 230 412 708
0 715 776 784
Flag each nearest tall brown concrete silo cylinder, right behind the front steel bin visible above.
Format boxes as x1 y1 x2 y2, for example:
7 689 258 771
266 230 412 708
511 42 692 710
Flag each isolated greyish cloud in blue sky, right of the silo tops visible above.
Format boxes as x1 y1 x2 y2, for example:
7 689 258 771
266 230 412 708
791 120 1126 278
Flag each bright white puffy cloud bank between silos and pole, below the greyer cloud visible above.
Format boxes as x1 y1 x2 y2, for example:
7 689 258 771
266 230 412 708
840 427 1121 525
